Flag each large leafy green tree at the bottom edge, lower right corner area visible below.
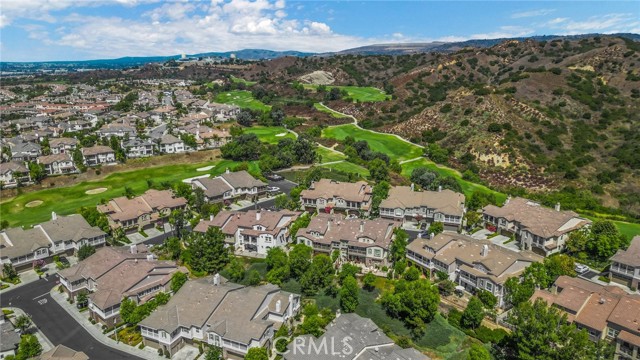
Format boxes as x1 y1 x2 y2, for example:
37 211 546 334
506 299 596 360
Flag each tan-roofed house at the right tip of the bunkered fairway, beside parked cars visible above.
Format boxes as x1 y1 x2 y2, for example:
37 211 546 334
191 169 267 203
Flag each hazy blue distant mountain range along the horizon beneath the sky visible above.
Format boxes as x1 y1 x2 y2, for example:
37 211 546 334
0 33 640 73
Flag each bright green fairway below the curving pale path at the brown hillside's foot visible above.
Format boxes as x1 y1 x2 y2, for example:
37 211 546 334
322 124 422 161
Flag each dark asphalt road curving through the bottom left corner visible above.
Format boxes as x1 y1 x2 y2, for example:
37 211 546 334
0 275 139 360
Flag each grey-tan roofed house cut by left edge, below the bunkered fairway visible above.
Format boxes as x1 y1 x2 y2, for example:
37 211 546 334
0 213 107 271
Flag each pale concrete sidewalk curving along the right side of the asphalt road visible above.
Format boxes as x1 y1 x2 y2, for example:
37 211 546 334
51 286 164 360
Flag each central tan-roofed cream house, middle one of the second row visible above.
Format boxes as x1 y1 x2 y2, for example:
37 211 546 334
297 213 400 266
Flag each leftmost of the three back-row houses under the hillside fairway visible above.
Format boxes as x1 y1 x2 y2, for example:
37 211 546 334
300 179 373 216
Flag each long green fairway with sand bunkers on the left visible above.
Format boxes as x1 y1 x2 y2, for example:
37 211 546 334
0 160 260 227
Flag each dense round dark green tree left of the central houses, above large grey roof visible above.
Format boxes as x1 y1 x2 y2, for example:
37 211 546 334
188 227 229 274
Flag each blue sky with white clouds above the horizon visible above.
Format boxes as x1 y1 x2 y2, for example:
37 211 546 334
0 0 640 61
